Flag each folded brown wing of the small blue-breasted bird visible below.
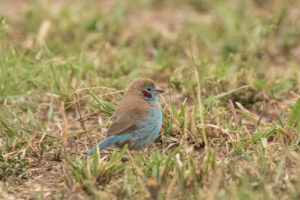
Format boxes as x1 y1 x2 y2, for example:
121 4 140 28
107 107 145 136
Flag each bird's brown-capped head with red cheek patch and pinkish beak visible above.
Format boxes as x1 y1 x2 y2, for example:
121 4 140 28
127 78 164 102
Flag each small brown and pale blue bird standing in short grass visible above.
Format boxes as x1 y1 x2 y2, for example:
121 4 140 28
87 78 164 157
